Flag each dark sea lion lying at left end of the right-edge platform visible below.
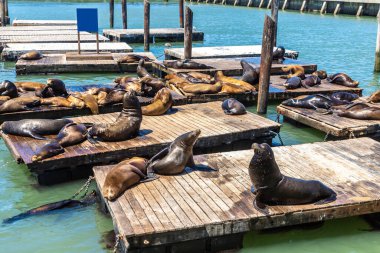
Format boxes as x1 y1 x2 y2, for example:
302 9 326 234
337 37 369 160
281 94 332 110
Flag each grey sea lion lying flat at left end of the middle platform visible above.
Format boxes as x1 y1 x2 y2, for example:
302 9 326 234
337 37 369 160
0 119 73 140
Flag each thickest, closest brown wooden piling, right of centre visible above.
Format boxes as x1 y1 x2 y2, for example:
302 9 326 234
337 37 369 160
257 15 275 114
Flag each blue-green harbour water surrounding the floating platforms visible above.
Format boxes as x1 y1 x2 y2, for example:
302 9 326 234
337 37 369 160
0 1 380 253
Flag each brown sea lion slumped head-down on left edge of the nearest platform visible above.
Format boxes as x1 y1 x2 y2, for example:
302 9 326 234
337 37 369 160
102 157 148 201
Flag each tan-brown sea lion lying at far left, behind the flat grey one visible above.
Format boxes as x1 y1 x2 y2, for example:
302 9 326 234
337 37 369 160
0 97 41 113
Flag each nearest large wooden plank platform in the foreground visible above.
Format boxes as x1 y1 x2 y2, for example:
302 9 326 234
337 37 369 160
93 138 380 249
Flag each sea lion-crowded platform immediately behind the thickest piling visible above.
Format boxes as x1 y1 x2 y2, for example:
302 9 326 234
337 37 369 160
169 75 363 103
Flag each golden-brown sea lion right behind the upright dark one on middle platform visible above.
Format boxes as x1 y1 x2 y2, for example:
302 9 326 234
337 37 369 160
141 88 173 116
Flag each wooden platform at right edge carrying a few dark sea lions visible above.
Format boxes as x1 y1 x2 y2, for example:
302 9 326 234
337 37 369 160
277 105 380 138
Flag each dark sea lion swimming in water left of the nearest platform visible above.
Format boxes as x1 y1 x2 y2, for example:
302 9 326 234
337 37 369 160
3 191 97 224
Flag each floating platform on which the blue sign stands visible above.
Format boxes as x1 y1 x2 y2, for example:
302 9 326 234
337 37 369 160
16 52 156 75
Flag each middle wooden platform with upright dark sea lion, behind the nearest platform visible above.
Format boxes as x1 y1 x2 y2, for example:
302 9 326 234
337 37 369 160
2 102 280 184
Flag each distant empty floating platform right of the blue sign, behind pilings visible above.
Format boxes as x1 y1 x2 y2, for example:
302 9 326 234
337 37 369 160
103 28 204 43
